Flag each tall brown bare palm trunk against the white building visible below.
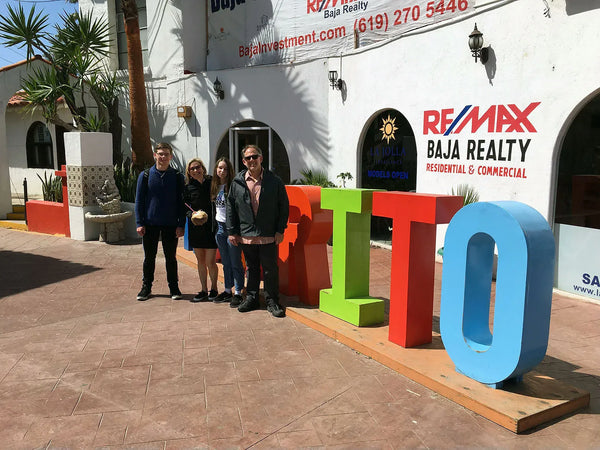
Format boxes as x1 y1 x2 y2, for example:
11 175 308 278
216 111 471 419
121 0 154 171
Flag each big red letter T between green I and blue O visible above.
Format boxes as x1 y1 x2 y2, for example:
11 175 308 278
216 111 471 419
373 192 463 347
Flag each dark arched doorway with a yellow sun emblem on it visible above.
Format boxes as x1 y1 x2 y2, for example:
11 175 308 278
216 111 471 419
358 109 417 241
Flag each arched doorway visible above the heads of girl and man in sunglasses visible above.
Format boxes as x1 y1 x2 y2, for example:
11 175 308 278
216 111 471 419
216 120 290 184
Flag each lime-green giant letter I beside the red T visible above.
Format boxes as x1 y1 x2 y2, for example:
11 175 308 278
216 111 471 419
319 189 384 326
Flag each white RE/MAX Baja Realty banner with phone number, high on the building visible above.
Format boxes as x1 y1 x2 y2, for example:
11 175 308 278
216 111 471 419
208 0 475 70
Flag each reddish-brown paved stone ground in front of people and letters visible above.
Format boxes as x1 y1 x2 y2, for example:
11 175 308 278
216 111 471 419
0 229 600 449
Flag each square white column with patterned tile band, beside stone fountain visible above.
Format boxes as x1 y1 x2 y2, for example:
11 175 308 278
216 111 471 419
65 132 113 241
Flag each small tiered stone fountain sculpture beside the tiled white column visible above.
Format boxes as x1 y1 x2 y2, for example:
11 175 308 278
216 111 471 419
85 179 133 243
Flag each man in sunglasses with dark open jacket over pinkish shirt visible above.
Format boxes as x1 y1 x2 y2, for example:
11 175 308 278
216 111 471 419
227 145 289 317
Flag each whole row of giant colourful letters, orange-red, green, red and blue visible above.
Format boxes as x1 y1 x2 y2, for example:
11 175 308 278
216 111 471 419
280 186 555 387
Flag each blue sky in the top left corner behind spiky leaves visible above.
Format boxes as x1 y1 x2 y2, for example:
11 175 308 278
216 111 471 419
0 0 77 67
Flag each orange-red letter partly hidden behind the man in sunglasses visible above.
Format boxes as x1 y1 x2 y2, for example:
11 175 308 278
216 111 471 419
279 186 333 305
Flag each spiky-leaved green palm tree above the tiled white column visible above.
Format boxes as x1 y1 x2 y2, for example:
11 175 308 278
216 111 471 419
0 4 124 162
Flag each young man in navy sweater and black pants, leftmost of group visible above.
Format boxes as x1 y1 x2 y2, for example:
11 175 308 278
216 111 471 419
135 142 185 301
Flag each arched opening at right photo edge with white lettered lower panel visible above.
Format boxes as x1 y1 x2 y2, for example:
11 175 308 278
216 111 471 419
554 94 600 300
